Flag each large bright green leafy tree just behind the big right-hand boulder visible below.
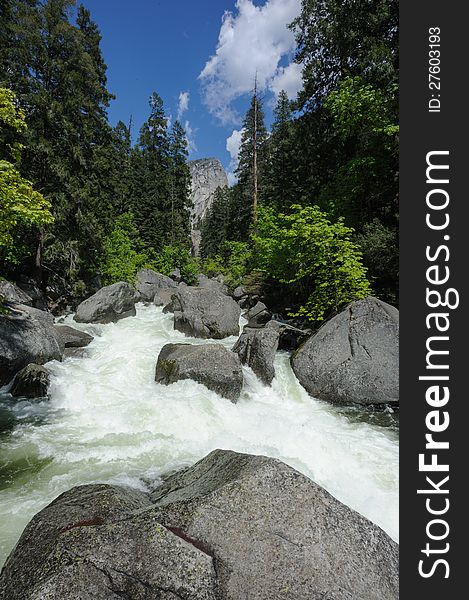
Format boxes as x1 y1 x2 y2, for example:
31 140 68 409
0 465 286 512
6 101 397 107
253 205 371 322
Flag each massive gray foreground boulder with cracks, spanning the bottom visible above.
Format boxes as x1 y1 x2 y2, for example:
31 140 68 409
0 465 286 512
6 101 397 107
0 450 399 600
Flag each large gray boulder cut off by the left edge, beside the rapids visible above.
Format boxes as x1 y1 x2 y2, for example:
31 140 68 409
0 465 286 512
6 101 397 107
0 304 64 385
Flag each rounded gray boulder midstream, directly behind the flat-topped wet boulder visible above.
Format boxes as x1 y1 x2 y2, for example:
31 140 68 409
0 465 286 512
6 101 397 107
164 286 241 339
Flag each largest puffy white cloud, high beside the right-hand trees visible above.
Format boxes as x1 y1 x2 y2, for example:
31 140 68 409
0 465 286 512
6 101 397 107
199 0 301 123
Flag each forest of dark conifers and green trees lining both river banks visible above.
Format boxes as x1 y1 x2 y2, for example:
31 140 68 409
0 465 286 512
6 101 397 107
0 0 398 323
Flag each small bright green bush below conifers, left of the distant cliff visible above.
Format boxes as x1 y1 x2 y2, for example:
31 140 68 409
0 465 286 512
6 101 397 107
101 213 148 285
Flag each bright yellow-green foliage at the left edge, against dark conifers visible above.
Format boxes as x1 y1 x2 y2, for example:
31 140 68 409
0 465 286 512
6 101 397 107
0 88 53 251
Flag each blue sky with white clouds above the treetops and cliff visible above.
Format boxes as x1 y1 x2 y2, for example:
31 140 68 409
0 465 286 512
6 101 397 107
82 0 300 180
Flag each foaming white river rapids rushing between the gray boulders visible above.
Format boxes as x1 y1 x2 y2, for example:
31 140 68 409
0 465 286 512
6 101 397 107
0 304 399 565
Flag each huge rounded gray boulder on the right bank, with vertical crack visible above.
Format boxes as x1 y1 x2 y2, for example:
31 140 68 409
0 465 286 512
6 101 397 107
292 296 399 405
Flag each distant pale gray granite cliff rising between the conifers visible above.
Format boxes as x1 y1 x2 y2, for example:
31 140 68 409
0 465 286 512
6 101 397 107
188 158 228 256
